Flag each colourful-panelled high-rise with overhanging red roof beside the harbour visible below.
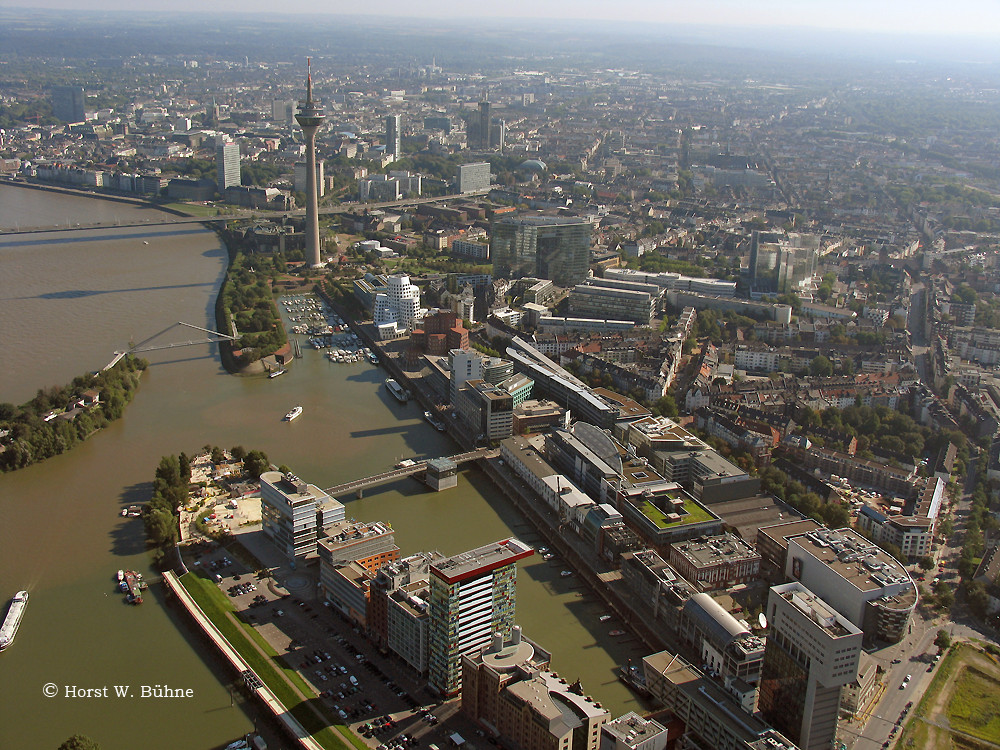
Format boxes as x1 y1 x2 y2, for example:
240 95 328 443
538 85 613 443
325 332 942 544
428 539 533 697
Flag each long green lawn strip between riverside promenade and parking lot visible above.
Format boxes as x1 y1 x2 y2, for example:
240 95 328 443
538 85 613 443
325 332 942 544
180 573 347 750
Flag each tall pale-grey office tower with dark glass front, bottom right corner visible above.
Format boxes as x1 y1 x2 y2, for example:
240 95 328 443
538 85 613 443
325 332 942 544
758 581 864 750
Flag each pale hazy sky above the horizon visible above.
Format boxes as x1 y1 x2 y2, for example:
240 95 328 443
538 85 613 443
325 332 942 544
11 0 1000 36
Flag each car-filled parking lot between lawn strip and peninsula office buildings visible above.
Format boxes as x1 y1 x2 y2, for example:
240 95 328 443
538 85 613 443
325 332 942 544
194 550 484 750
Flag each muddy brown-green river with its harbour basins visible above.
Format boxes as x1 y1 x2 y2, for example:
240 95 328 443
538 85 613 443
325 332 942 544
0 185 638 750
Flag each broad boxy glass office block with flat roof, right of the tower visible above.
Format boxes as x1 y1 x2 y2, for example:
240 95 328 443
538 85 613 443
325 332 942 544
490 216 593 286
